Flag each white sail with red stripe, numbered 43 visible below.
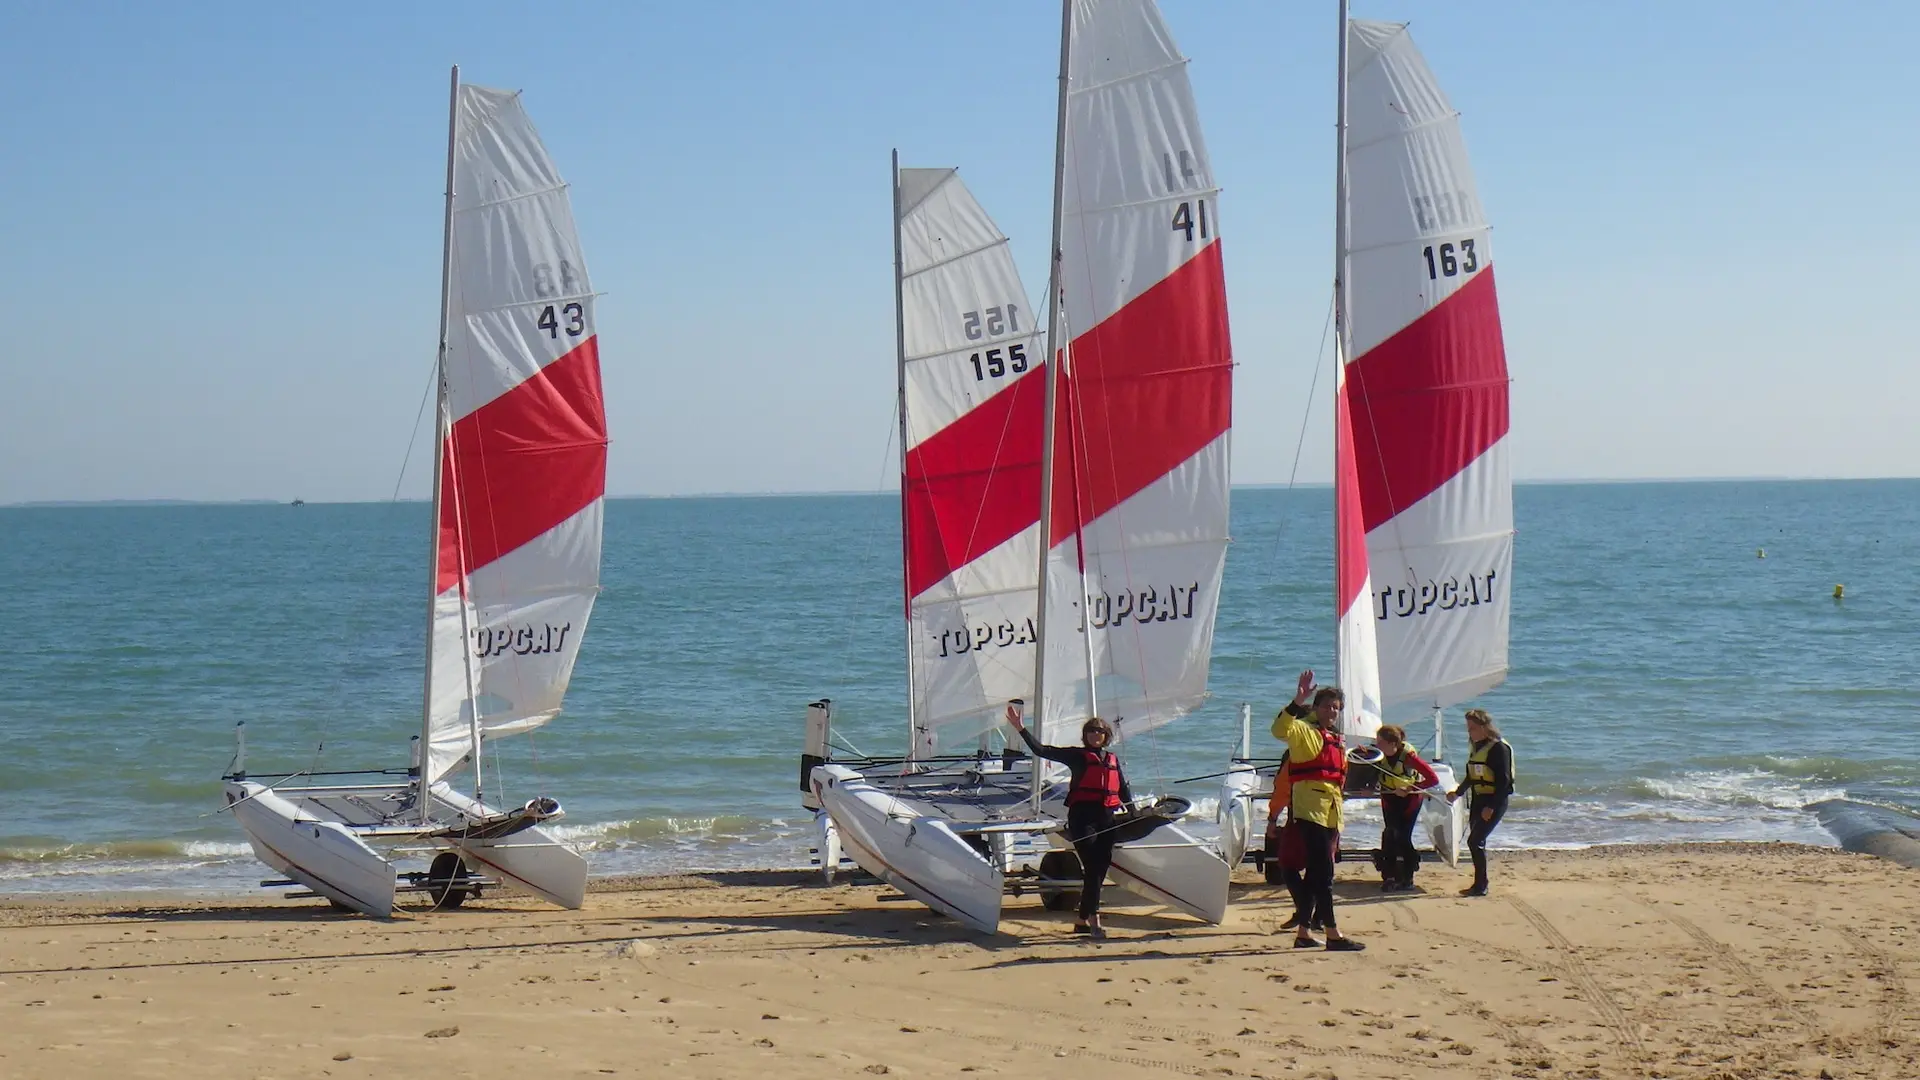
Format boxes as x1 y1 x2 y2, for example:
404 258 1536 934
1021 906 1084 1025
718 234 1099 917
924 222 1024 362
424 85 607 782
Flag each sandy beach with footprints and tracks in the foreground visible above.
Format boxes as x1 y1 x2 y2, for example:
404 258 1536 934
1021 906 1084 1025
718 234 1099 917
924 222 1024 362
0 844 1920 1080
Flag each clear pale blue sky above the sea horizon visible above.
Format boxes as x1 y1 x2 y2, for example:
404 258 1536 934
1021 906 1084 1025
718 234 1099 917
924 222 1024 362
0 0 1920 503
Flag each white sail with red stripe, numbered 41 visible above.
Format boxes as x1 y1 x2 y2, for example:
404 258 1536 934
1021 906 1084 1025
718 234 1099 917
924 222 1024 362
1041 0 1233 738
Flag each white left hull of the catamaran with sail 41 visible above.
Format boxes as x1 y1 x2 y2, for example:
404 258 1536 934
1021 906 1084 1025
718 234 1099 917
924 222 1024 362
812 765 1006 934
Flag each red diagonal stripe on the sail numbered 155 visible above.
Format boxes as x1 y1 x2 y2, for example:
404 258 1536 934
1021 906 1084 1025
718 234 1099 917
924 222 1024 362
900 372 1046 598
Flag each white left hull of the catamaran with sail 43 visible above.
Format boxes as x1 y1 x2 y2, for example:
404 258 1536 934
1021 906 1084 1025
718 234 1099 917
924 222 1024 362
227 780 396 919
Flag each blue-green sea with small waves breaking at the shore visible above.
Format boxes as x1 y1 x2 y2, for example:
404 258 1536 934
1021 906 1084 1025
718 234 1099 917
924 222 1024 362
0 480 1920 892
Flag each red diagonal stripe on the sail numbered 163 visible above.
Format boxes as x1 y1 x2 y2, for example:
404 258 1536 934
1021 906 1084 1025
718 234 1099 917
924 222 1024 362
1346 267 1507 532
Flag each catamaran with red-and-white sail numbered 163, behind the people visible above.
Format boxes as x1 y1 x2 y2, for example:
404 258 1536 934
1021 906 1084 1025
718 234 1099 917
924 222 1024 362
1229 0 1513 863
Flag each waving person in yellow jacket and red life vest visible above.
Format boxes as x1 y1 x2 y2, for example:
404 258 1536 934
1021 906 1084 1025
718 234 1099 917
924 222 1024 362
1273 671 1367 953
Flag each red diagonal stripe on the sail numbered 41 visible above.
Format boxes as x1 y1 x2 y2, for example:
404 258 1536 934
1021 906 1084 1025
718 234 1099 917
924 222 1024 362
1052 240 1233 544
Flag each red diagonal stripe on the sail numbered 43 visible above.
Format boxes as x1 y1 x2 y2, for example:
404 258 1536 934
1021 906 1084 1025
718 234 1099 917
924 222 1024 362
434 336 607 592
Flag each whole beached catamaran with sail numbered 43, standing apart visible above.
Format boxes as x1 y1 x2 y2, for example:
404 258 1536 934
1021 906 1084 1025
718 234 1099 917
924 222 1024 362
227 67 607 917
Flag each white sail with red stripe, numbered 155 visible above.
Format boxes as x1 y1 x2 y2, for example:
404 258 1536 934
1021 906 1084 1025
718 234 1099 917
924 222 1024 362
899 169 1046 755
